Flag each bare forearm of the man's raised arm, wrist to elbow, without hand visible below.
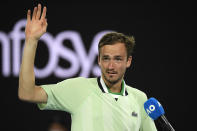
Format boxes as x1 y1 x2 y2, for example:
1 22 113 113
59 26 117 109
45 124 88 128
18 39 38 100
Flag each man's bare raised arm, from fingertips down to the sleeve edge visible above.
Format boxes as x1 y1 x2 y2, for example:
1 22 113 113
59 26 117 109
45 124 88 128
18 4 47 103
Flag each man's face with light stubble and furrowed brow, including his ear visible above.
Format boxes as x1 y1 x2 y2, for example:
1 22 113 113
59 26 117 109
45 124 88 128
98 43 132 84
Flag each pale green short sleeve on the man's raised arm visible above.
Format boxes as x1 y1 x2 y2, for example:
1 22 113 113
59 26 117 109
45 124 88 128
38 77 92 113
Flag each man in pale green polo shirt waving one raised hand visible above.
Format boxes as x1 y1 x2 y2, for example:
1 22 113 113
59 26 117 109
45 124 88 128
18 4 156 131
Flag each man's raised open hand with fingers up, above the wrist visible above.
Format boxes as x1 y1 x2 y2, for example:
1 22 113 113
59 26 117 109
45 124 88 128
25 4 48 40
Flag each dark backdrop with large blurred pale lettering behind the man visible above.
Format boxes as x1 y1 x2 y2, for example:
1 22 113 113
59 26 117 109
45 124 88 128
0 0 193 131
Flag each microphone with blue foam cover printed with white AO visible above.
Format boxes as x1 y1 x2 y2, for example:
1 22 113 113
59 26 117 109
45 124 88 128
144 97 175 131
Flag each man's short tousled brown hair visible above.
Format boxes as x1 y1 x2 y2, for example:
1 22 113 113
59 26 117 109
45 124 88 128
98 32 135 58
